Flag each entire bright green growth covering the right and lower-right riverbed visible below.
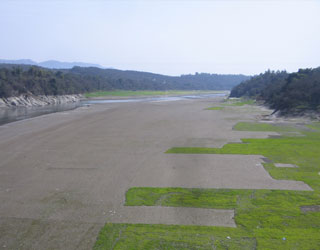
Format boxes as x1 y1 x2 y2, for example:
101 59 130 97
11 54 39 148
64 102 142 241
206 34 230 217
94 123 320 250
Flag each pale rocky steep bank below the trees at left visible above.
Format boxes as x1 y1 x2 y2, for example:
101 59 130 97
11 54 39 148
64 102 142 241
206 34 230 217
0 94 83 108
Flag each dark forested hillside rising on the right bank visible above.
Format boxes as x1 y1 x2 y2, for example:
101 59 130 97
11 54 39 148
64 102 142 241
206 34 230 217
230 67 320 113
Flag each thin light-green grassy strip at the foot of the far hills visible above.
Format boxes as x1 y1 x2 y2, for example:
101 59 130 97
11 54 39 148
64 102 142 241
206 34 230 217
85 90 223 98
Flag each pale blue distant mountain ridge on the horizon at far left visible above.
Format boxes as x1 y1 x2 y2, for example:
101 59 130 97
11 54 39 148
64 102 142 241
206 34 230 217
0 59 103 69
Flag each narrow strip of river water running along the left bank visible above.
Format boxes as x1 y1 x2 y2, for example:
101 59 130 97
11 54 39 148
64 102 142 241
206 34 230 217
0 92 228 125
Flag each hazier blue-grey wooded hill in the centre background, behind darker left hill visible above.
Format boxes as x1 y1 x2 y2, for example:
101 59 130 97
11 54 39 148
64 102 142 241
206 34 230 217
69 67 250 90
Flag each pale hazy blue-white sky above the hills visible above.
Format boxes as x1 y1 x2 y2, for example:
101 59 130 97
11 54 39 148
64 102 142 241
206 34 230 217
0 0 320 75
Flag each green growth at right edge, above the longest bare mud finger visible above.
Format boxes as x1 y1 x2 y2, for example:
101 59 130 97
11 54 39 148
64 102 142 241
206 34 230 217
166 123 320 191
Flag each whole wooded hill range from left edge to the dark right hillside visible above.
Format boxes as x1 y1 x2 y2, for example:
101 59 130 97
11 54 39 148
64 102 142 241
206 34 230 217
0 64 249 97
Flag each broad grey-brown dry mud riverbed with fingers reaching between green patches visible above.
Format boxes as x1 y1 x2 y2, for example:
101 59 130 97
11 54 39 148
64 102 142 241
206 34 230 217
0 99 310 249
